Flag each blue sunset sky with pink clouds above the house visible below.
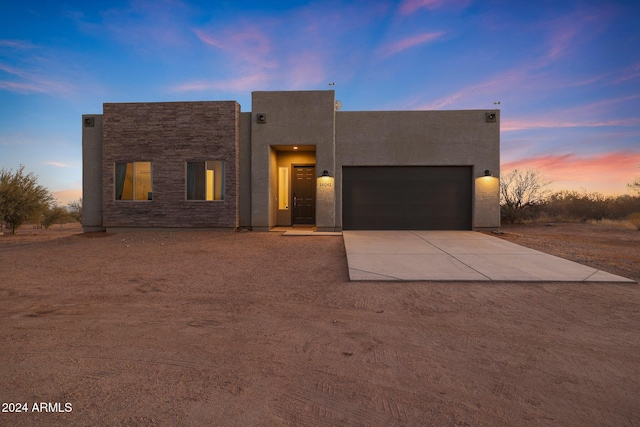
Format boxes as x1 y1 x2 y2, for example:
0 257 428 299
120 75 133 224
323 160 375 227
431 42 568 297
0 0 640 204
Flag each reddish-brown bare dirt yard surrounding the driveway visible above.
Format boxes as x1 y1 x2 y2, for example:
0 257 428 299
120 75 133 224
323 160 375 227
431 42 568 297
0 224 640 427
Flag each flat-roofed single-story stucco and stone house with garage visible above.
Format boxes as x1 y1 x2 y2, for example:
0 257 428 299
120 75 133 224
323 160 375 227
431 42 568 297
82 90 500 231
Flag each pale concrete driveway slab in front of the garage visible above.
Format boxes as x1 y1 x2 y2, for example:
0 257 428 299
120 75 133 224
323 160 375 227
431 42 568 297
342 231 635 283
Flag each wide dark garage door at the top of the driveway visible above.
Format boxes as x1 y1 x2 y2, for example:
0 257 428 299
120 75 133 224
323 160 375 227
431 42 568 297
342 166 472 230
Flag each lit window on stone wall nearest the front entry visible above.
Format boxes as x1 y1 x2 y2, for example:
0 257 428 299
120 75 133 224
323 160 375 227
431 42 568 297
187 160 224 200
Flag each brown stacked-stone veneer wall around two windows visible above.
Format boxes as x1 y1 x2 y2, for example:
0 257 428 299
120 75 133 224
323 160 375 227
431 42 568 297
102 101 240 228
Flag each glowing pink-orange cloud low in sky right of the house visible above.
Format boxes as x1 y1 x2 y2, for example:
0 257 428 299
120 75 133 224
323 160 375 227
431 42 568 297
501 152 640 194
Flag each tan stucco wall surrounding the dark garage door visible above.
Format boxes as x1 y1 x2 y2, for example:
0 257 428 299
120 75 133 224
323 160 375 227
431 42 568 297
335 110 500 228
